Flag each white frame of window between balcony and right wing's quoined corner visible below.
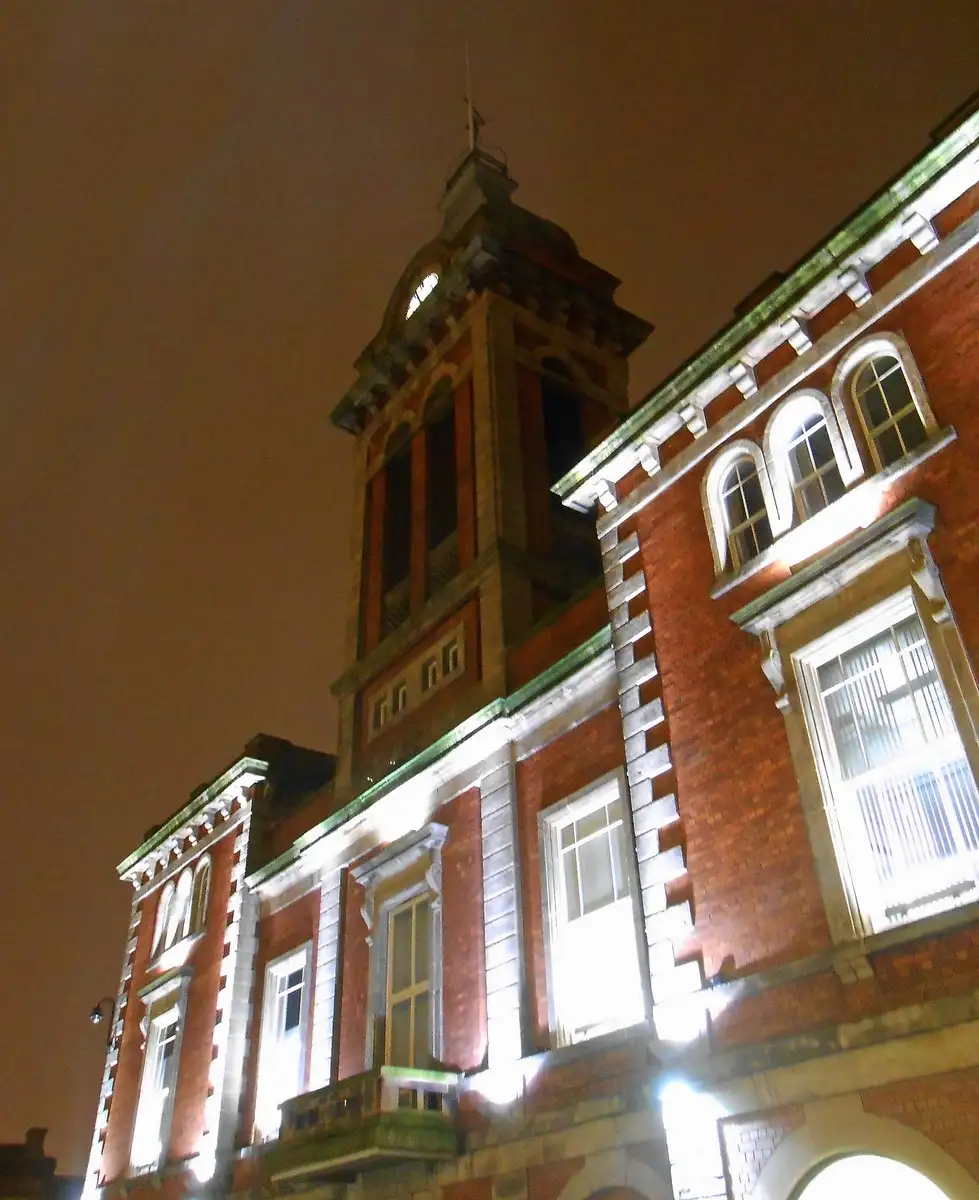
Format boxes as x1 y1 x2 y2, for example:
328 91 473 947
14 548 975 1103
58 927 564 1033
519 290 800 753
537 770 648 1046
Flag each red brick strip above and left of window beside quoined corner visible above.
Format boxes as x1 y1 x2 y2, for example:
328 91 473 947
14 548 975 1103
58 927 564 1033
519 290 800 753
517 706 625 1049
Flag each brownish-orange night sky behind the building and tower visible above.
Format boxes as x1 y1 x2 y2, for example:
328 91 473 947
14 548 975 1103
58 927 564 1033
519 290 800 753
0 0 979 1171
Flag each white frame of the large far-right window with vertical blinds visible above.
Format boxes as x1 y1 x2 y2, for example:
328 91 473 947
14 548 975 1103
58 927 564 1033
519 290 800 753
792 587 979 936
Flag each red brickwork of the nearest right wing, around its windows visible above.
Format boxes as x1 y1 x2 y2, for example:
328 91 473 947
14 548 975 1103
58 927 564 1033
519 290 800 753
619 234 979 1003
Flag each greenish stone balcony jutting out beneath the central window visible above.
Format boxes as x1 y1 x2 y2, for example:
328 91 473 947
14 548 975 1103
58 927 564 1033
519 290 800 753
264 1067 458 1188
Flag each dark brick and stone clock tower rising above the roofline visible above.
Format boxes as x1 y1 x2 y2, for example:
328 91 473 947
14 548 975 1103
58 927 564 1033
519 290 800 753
332 145 651 799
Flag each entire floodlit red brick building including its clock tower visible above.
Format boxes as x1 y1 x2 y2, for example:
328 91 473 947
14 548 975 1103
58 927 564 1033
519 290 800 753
80 96 979 1200
